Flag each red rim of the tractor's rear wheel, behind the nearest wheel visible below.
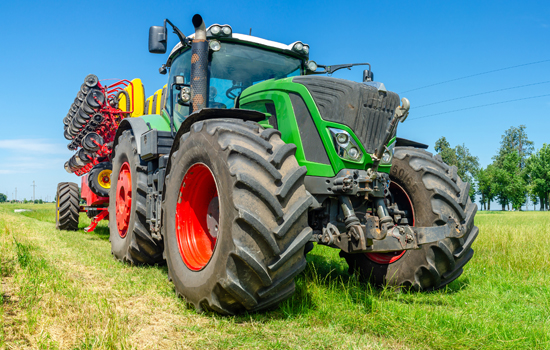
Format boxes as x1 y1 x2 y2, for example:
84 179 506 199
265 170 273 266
115 162 132 238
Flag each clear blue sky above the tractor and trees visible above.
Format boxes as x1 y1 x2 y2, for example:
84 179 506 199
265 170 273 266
0 0 550 205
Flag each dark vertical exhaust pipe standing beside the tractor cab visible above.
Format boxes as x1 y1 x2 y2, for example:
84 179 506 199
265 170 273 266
194 14 208 112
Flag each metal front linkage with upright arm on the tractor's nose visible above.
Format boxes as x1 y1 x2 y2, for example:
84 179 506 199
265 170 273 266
312 98 466 253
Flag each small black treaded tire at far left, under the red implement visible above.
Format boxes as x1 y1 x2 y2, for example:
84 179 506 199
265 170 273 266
55 182 80 231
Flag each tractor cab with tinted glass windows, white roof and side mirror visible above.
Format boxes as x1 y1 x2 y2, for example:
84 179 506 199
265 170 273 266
149 17 309 129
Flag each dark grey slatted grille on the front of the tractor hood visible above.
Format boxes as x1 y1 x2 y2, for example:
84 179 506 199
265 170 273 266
292 76 399 153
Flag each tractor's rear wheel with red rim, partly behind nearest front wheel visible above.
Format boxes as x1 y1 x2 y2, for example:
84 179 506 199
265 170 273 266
109 130 163 265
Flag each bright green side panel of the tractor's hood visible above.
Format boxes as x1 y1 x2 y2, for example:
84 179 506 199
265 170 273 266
239 78 393 177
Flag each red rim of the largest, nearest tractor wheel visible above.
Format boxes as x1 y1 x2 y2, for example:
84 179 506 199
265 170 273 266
176 164 219 271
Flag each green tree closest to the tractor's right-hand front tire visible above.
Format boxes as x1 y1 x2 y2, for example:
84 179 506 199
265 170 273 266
434 136 479 202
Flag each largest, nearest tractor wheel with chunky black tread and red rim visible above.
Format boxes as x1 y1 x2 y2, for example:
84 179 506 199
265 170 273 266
162 119 312 314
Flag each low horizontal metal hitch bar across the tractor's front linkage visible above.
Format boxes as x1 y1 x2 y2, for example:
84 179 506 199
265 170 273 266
319 217 465 253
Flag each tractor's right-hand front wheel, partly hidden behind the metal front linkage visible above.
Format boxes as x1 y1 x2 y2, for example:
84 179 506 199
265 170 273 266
340 147 479 291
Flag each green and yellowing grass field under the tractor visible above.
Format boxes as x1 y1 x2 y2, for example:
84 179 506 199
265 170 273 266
0 204 550 349
